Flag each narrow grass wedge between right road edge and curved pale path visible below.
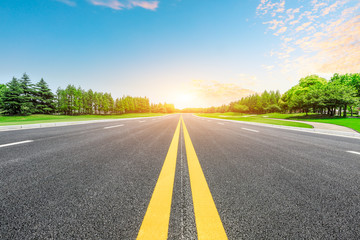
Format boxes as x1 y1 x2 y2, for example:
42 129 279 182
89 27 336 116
196 112 313 128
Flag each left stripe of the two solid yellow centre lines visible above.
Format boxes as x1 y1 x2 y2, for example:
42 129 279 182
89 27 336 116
136 118 182 240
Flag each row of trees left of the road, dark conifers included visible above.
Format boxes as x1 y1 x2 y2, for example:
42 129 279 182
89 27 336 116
0 74 175 115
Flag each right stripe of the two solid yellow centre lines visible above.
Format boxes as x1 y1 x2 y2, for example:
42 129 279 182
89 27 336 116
182 120 227 240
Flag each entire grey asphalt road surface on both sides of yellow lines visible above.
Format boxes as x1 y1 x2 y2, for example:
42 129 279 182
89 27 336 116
0 114 360 239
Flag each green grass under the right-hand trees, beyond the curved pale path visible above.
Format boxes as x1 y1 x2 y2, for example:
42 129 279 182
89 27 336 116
259 113 360 132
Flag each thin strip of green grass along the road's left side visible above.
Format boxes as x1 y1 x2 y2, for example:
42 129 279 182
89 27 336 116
0 113 166 126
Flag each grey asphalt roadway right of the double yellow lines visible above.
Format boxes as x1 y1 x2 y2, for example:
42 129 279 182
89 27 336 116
184 115 360 239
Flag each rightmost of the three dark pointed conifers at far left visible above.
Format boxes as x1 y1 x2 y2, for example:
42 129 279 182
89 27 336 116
35 78 55 113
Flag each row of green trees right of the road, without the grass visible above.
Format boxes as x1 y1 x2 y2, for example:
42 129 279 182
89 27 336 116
183 73 360 117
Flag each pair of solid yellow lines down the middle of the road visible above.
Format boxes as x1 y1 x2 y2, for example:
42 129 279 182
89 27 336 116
137 117 227 240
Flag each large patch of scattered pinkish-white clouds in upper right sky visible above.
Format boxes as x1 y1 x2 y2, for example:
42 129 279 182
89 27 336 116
256 0 360 76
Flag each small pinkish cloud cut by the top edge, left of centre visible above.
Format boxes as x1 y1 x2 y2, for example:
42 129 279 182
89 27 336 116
89 0 159 11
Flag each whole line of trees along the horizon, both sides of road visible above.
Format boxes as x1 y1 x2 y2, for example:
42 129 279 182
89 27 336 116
0 73 360 117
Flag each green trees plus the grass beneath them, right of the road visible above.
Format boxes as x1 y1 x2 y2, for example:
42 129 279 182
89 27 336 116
188 73 360 131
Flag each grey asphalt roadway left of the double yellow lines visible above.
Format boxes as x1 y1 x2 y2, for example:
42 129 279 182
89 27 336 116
0 115 179 239
